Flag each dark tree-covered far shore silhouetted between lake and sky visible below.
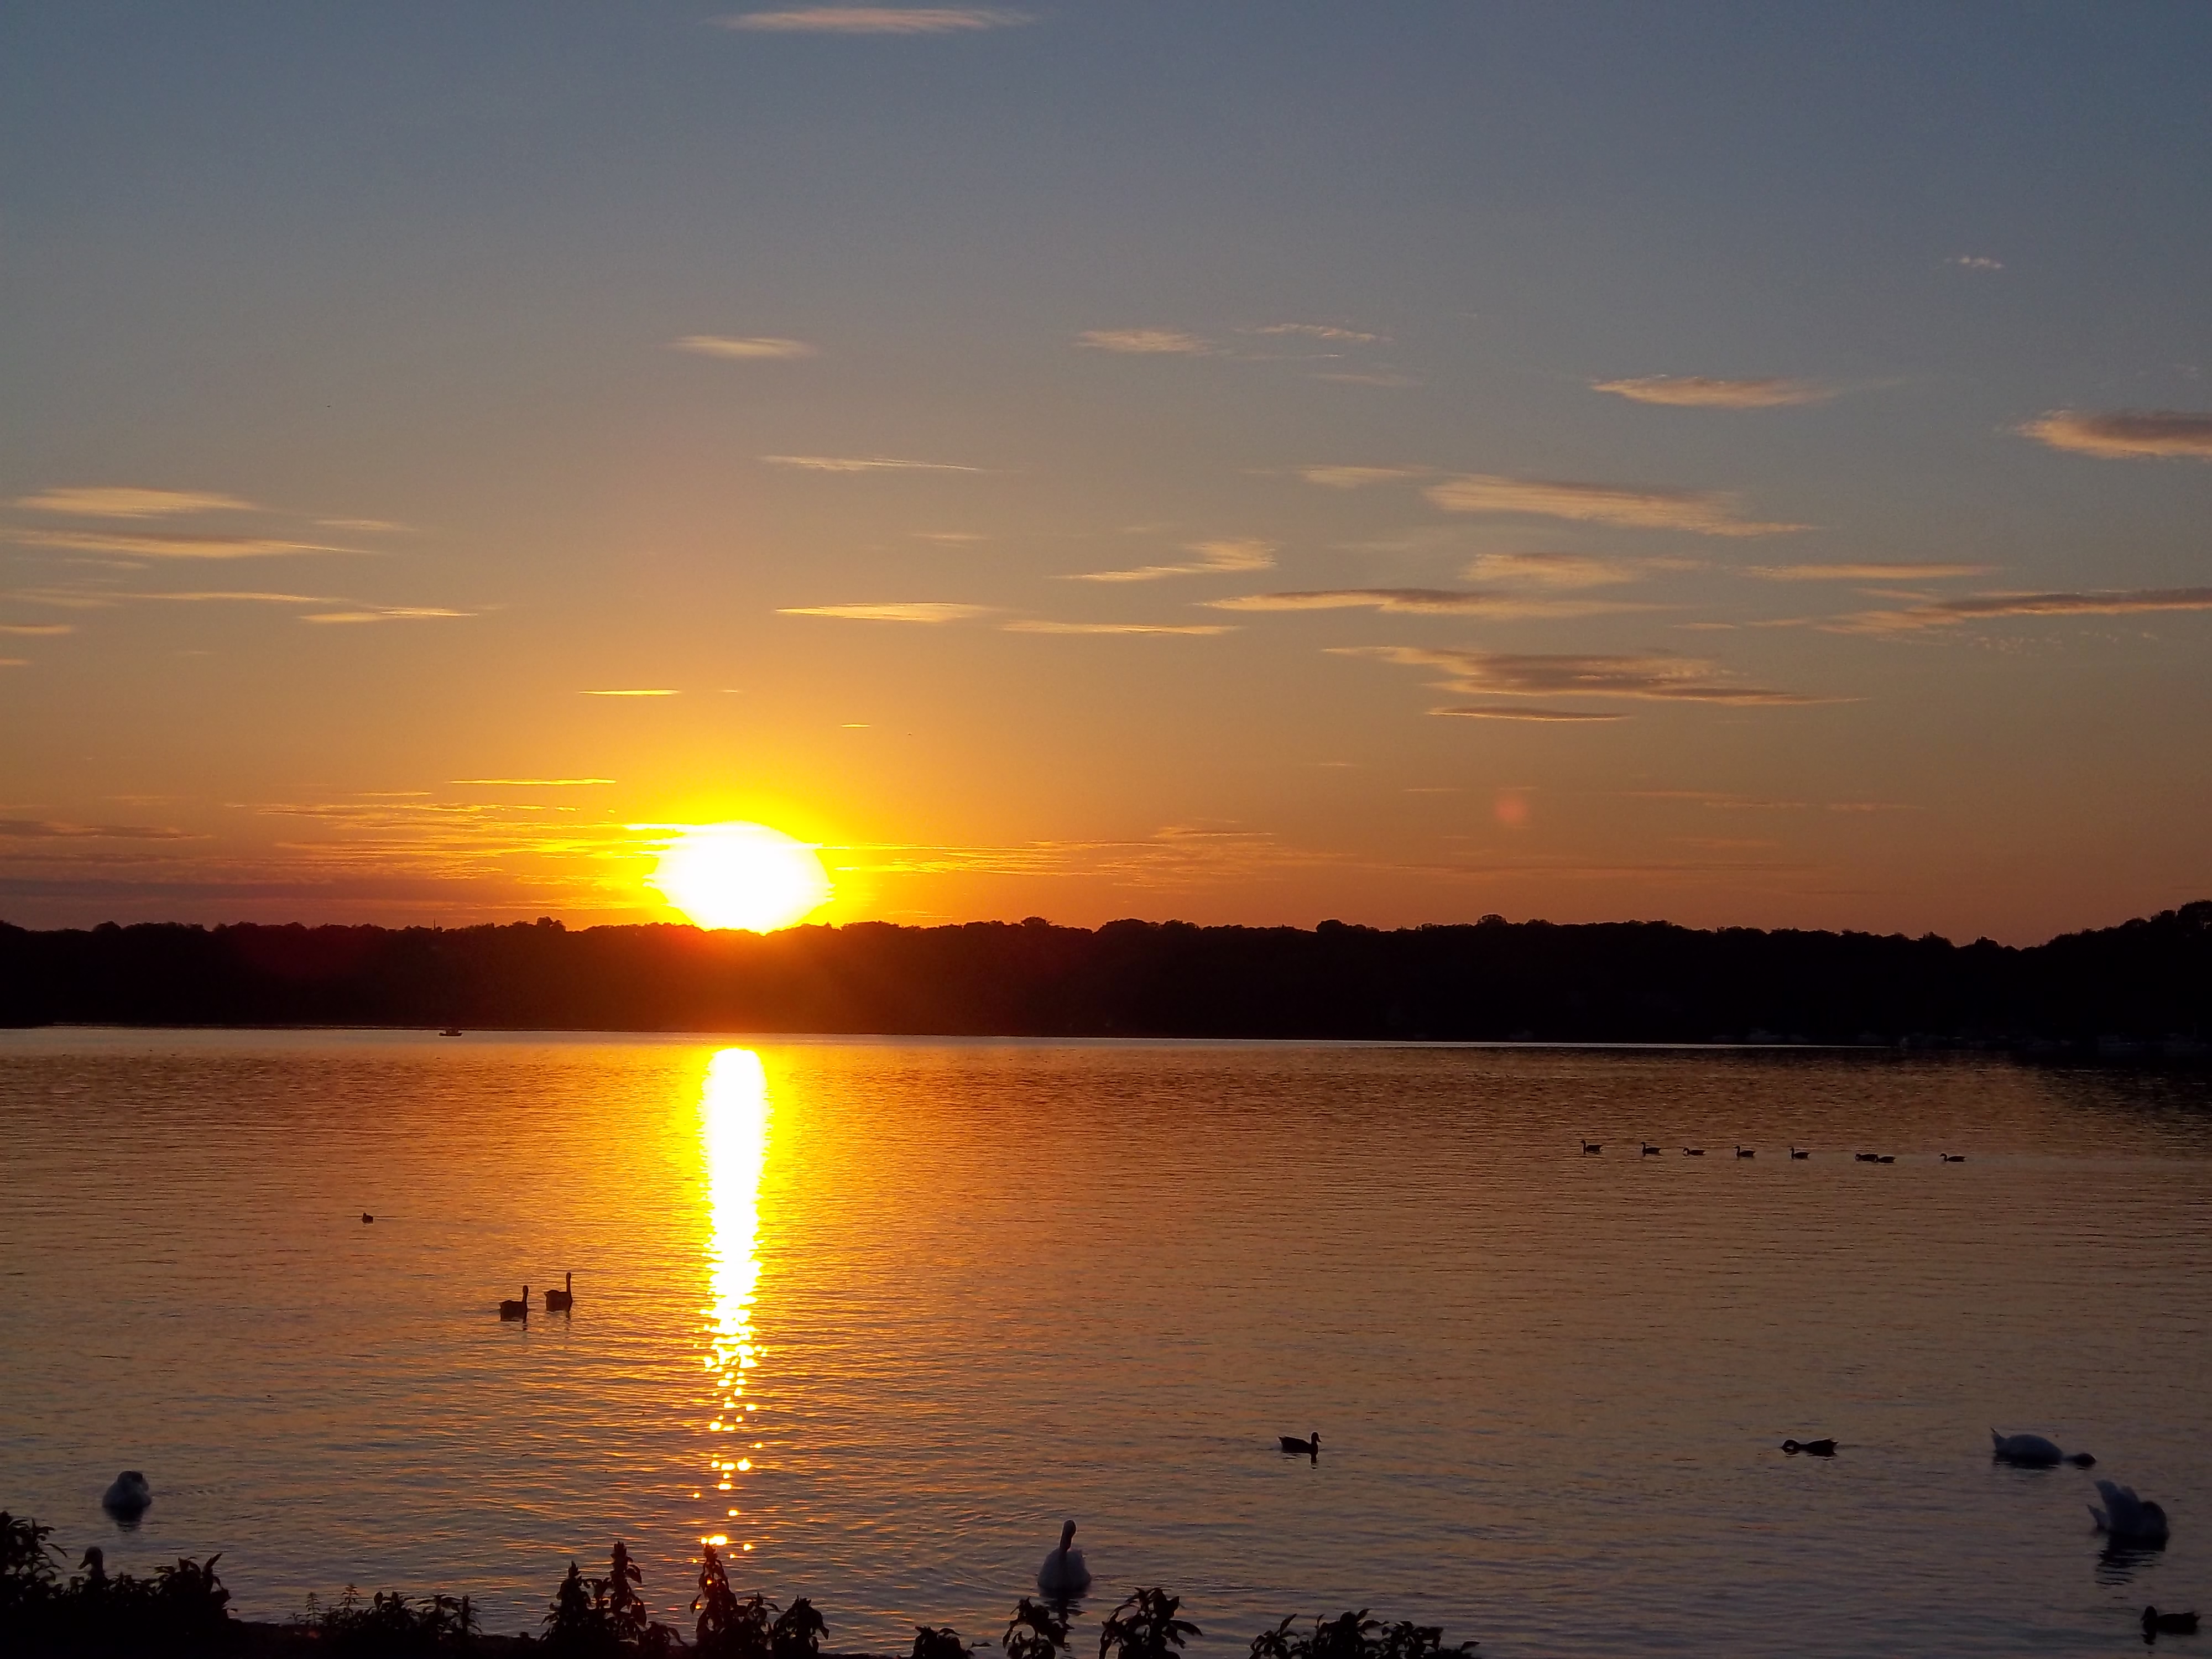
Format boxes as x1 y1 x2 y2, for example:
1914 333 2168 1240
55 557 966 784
0 900 2212 1057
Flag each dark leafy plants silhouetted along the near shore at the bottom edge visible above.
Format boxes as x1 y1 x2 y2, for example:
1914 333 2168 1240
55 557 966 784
0 1511 1478 1659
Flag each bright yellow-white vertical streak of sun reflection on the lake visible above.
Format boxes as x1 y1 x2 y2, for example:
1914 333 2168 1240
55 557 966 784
699 1048 768 1551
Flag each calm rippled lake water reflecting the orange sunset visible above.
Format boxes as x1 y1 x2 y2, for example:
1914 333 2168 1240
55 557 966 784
0 1031 2212 1659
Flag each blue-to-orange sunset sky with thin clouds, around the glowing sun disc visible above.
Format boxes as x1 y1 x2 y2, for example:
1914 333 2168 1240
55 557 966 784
0 0 2212 942
